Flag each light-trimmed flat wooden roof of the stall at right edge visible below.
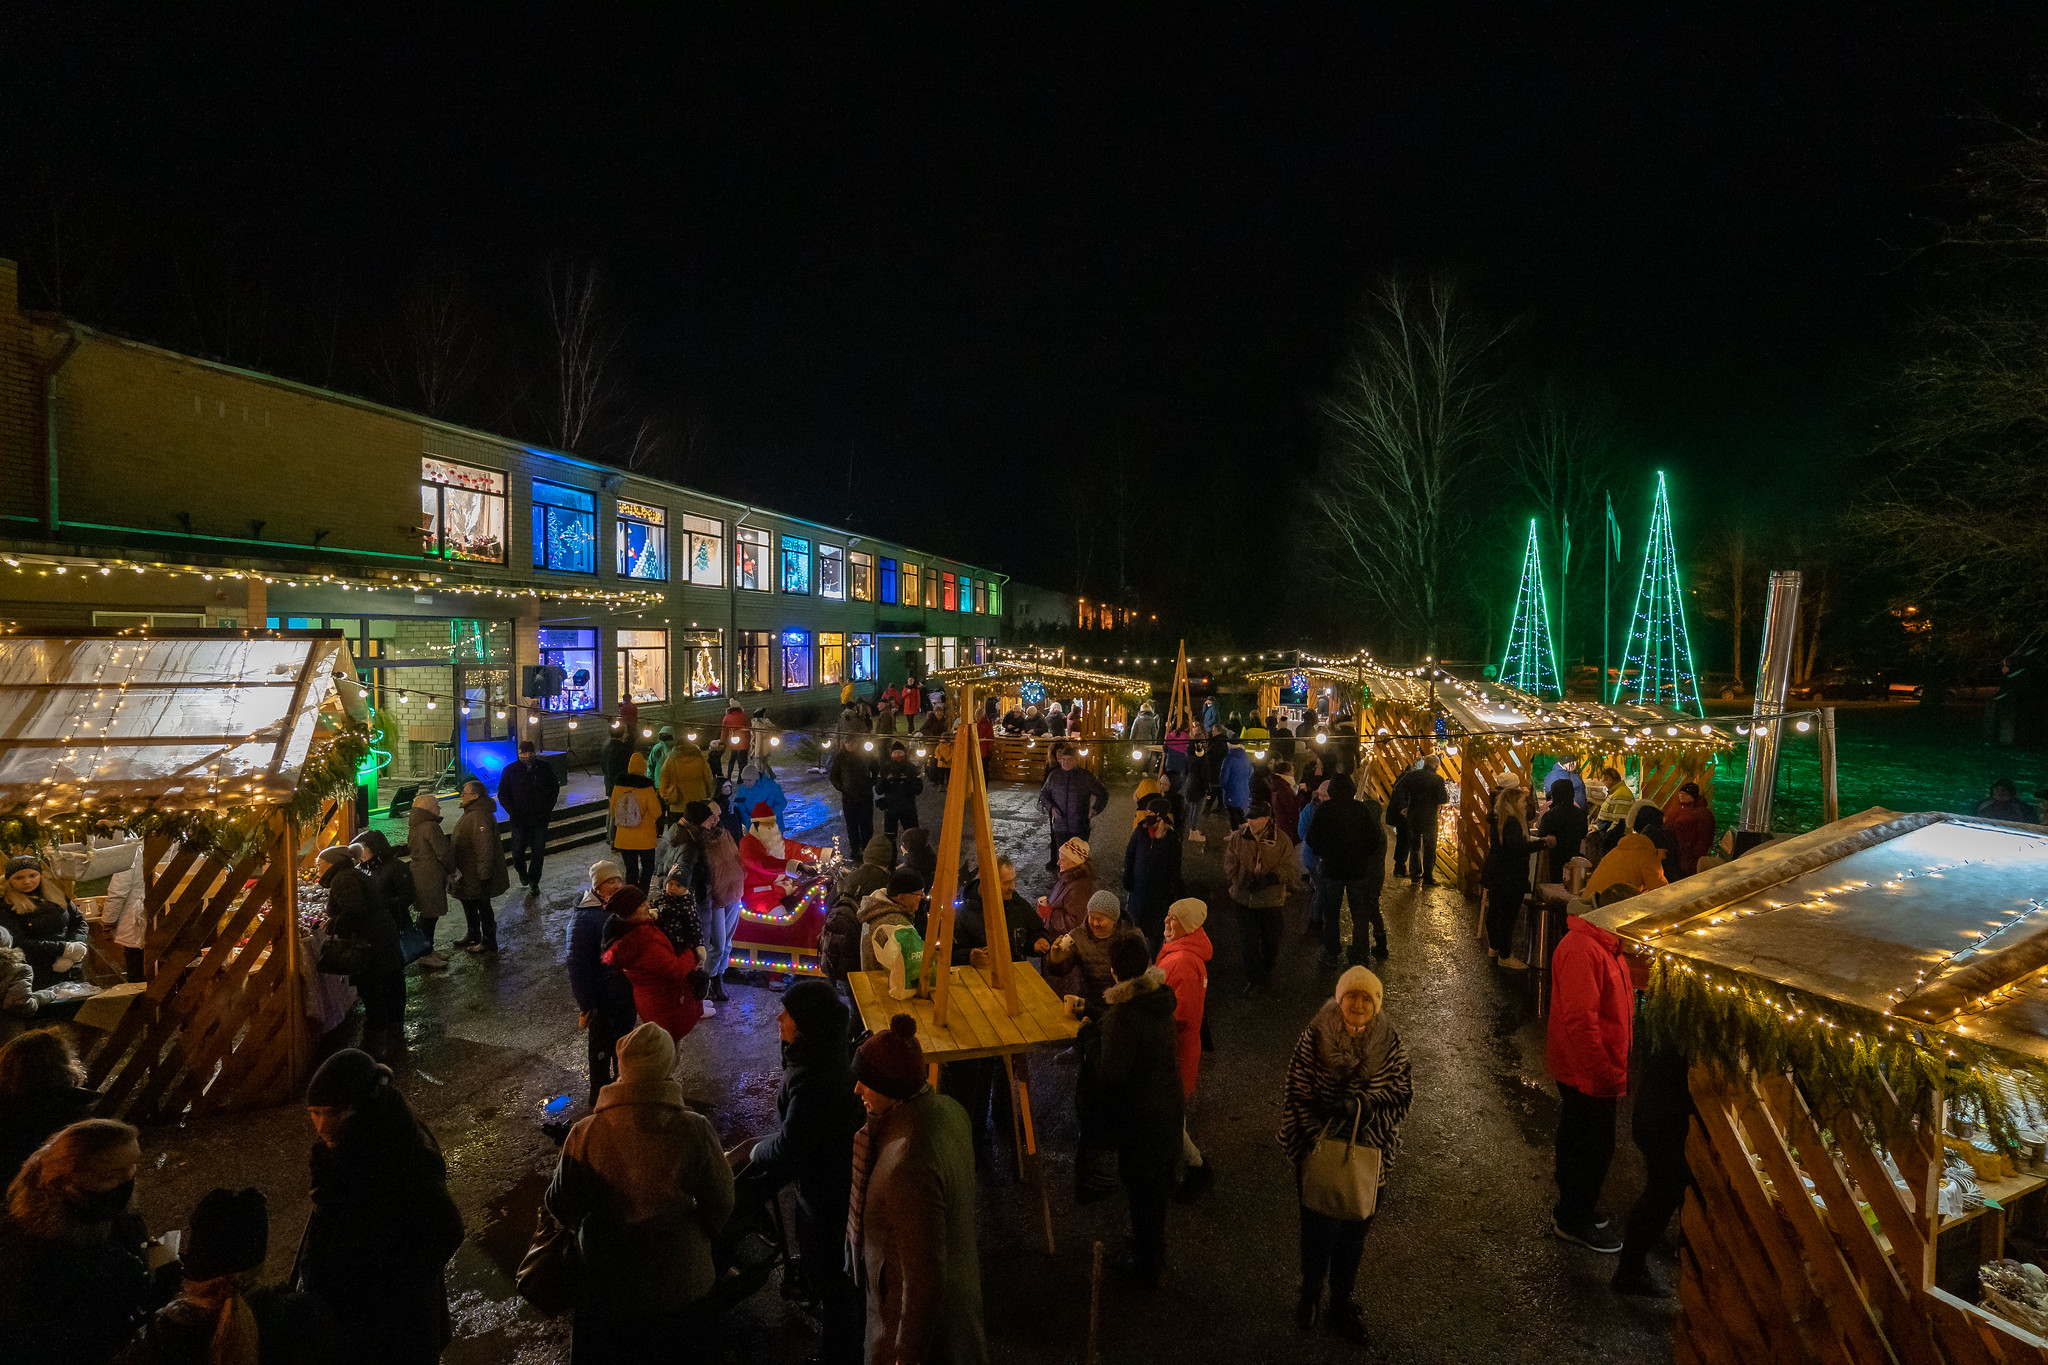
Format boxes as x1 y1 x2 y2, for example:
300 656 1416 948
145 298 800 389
1585 808 2048 1060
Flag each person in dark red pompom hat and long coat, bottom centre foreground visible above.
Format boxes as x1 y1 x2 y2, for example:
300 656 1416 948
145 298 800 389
846 1015 989 1365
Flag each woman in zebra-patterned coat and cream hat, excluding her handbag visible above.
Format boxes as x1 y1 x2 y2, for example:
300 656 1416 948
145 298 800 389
1280 966 1415 1345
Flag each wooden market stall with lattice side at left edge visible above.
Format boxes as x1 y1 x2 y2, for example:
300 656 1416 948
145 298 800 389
0 630 367 1121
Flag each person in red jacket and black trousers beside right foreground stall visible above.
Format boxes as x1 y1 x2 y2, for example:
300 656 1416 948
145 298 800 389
1544 915 1636 1257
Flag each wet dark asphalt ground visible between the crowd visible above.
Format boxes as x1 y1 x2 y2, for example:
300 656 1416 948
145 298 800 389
137 765 1675 1365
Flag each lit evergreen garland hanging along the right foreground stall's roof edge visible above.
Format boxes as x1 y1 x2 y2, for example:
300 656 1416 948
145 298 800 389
1642 954 2048 1150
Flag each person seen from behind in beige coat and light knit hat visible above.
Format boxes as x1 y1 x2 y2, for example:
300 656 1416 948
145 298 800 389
541 1023 733 1365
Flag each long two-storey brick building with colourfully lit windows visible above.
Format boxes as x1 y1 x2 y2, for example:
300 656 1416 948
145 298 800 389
0 260 1008 778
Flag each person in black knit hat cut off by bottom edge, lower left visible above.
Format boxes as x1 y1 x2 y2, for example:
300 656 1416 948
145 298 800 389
119 1189 340 1365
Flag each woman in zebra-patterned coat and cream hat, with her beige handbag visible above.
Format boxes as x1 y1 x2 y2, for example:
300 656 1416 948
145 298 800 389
1280 966 1415 1345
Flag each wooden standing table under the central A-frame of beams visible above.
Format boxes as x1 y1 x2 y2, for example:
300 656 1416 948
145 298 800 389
846 962 1081 1254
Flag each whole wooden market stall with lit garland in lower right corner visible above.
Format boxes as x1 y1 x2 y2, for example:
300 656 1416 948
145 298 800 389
1587 810 2048 1365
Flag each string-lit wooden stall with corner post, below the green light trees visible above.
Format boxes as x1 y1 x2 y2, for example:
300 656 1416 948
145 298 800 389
1247 655 1735 896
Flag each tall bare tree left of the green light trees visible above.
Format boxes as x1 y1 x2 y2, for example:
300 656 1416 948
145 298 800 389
1311 276 1505 655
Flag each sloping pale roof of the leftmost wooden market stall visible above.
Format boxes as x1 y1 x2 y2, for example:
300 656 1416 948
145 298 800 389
0 634 365 812
